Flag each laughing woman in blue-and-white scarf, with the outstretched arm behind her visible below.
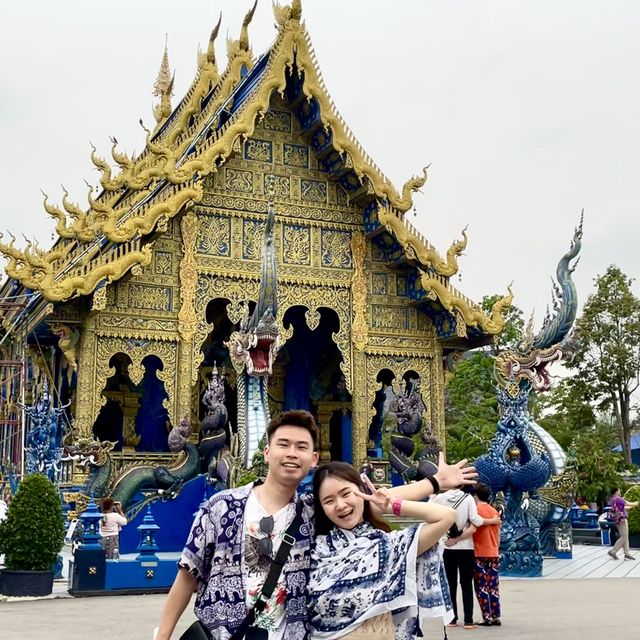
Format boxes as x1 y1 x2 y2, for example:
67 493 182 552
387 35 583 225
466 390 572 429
309 458 474 640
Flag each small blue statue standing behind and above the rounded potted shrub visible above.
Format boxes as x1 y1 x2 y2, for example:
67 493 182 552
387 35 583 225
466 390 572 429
21 378 69 482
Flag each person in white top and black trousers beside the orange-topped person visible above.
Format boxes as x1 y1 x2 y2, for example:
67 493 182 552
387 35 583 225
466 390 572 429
432 489 500 629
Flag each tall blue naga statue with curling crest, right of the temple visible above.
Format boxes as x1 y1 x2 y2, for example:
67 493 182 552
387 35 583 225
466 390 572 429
475 218 582 576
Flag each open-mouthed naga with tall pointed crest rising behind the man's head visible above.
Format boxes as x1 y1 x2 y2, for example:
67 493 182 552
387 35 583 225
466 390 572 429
225 193 280 468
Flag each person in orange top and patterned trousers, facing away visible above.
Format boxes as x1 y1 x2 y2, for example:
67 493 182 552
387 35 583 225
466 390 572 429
471 482 502 627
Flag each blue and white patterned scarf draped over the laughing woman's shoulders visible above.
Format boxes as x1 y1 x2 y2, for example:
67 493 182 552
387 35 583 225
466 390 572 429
309 523 453 640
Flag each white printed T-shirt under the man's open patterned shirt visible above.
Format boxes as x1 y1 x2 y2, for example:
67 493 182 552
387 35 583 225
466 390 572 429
244 491 295 640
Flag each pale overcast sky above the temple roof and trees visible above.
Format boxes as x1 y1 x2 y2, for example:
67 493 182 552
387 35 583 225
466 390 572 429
0 0 640 330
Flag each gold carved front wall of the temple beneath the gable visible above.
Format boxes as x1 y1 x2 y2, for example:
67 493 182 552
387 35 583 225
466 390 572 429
70 96 444 462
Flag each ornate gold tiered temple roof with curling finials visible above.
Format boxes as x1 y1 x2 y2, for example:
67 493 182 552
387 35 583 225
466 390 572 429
0 0 510 334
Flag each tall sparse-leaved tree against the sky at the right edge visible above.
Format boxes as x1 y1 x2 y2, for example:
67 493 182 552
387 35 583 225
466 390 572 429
571 265 640 464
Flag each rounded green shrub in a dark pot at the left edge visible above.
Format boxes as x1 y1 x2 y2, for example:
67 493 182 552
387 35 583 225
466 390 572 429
0 473 64 596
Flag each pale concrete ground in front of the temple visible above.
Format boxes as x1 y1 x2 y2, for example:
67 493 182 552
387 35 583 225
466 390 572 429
0 578 640 640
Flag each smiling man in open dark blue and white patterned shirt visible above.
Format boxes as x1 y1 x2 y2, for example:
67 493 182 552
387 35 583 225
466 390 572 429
157 411 318 640
